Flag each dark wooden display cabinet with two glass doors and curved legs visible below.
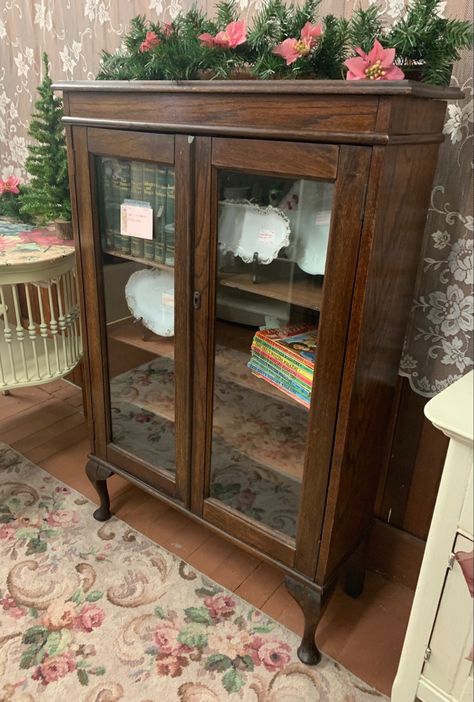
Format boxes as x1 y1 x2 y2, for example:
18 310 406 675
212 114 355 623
55 81 460 664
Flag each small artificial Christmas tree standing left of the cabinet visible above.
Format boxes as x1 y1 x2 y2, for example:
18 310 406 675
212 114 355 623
19 54 71 224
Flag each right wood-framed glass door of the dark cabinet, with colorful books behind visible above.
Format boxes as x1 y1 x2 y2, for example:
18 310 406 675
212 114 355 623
194 139 368 574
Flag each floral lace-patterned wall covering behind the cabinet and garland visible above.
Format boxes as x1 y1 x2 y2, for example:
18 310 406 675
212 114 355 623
0 0 474 397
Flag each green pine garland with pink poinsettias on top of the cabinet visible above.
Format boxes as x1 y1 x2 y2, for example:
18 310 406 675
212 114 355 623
97 0 473 85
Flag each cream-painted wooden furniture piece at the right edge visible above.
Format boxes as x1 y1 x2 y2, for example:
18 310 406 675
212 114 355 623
392 372 474 702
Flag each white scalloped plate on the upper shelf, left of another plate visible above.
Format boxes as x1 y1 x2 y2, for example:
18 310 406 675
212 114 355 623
219 200 290 264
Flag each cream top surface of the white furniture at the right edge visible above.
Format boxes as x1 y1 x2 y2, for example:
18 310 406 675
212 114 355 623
425 371 474 442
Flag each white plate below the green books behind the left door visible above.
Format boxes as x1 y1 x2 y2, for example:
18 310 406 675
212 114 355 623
125 268 174 336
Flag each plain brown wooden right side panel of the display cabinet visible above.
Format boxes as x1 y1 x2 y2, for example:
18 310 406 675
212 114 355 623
317 144 438 581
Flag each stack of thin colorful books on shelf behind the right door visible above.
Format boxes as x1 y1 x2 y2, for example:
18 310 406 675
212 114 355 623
247 324 317 408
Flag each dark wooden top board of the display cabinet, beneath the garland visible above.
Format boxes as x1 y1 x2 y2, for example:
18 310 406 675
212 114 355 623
53 80 463 100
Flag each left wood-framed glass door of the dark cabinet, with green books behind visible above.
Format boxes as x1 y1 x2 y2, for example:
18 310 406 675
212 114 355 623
74 129 190 500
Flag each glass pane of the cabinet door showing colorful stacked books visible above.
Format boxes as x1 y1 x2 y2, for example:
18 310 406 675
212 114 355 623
209 170 334 539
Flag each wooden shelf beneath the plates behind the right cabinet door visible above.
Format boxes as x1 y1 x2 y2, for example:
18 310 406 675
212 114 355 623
219 272 323 311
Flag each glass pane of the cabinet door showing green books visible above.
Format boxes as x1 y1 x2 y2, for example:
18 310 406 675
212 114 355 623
95 156 176 474
